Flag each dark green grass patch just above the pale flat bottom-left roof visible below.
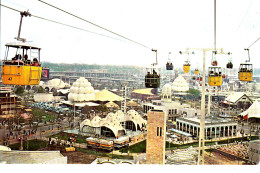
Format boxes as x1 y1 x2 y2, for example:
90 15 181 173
9 140 48 151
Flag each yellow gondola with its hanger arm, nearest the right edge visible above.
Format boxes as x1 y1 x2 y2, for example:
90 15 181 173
238 49 253 82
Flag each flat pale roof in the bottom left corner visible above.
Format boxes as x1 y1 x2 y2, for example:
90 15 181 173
0 151 66 164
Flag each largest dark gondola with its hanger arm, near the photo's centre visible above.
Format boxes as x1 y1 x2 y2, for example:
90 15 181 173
145 49 161 88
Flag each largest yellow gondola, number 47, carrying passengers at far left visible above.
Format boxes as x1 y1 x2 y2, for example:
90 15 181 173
2 42 42 85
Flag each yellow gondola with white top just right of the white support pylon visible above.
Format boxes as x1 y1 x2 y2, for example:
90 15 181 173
208 66 222 86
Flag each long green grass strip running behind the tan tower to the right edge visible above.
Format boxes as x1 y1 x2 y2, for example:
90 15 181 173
120 136 258 153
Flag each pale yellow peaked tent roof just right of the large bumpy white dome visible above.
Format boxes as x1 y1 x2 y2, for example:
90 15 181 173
95 89 123 101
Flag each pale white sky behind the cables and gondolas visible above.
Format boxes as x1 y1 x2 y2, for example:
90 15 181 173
0 0 260 69
